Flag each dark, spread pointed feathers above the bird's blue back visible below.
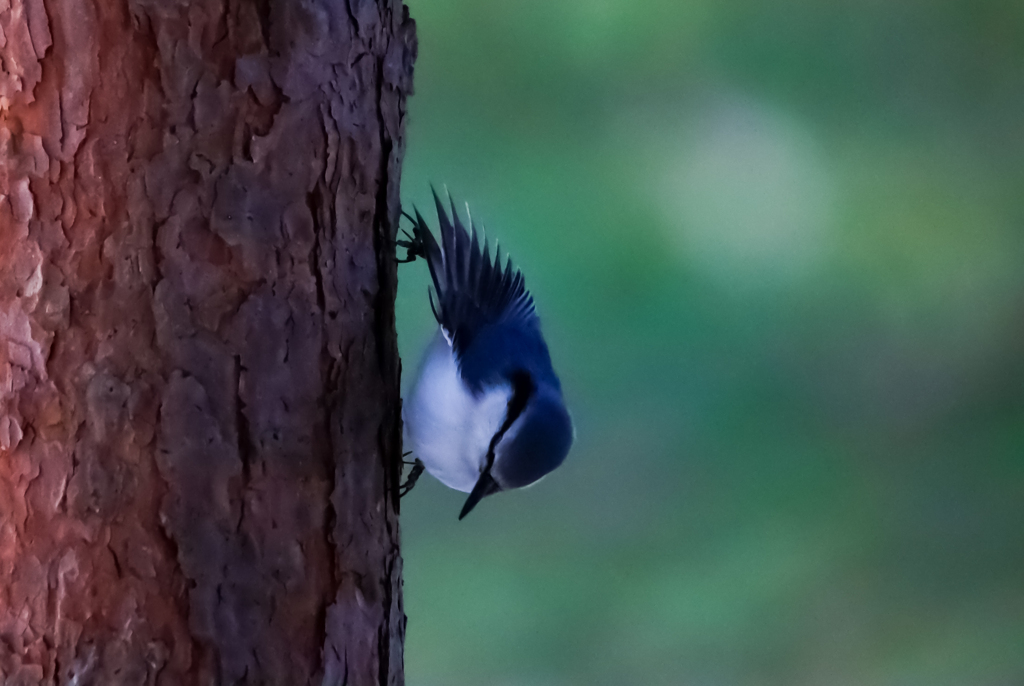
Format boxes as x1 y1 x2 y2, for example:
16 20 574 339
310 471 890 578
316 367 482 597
414 191 537 357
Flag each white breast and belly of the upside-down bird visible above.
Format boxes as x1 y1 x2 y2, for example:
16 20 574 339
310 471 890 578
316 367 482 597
402 333 512 492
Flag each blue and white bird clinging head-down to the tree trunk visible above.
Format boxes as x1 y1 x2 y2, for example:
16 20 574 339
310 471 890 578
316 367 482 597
397 189 575 520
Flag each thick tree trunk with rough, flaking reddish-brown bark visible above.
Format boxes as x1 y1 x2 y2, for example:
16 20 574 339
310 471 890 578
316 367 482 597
0 0 416 686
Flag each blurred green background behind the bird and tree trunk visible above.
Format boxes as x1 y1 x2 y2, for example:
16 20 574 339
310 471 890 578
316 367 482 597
398 0 1024 686
